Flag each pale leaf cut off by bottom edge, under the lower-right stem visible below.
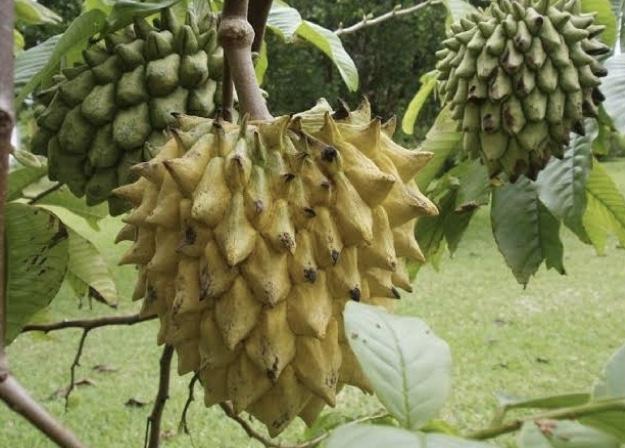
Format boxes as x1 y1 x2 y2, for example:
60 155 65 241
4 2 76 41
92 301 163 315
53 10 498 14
518 420 620 448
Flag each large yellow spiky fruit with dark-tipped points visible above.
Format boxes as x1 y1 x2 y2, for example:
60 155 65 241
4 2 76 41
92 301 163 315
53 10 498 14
115 102 437 435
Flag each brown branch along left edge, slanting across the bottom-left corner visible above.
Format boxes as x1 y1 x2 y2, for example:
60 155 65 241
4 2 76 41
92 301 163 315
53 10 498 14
0 4 83 448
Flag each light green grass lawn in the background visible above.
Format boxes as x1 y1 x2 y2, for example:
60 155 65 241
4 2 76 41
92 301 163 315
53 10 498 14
0 161 625 448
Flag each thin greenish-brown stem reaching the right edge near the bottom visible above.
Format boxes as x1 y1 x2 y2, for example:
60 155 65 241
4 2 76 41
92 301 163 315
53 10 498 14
467 399 625 440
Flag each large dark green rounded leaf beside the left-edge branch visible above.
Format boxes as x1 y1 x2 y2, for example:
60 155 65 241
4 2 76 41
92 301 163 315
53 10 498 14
5 202 68 342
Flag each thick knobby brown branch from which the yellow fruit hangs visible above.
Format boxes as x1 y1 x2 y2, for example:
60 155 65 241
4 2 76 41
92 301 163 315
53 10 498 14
218 0 272 120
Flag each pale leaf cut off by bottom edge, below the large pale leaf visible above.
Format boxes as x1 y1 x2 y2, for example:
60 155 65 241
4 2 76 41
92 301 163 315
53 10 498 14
325 424 425 448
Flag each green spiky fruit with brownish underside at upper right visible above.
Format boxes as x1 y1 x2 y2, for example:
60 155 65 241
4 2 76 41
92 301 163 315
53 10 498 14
437 0 610 180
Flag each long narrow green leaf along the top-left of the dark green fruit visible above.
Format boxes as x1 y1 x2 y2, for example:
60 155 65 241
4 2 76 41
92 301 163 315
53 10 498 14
16 9 106 108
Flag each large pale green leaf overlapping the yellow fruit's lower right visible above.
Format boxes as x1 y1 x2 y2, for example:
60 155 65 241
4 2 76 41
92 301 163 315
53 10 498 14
343 302 451 429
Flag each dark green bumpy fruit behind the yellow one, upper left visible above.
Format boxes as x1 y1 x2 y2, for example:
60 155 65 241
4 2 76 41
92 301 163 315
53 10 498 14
31 9 223 215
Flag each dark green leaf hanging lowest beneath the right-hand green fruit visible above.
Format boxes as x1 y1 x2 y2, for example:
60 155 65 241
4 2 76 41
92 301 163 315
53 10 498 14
491 177 564 285
